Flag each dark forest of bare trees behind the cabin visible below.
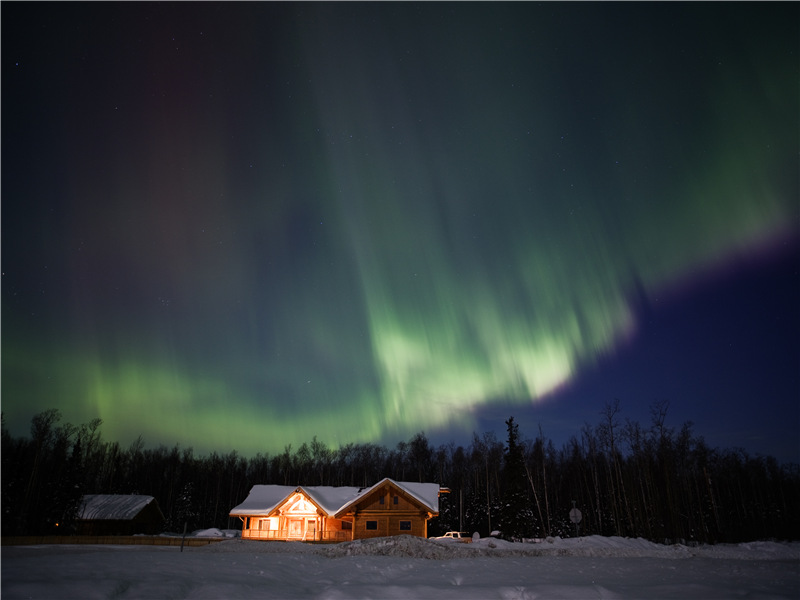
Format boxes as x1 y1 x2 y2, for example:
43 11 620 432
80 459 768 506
1 400 800 544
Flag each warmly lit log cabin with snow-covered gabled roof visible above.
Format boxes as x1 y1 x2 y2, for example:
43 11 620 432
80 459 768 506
230 478 439 542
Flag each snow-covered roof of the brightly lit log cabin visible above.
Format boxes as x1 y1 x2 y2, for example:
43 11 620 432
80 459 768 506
229 477 439 516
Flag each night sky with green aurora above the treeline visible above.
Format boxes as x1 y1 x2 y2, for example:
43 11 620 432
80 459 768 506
2 3 800 462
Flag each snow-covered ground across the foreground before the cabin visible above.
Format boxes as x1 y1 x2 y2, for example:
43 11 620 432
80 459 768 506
0 532 800 600
